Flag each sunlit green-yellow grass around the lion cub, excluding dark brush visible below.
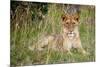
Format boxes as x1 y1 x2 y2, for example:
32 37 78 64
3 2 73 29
11 4 95 65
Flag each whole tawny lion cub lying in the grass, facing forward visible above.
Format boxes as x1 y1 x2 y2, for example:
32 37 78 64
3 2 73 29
30 14 86 54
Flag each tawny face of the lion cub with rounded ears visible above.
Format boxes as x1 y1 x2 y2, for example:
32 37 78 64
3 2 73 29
62 14 79 37
